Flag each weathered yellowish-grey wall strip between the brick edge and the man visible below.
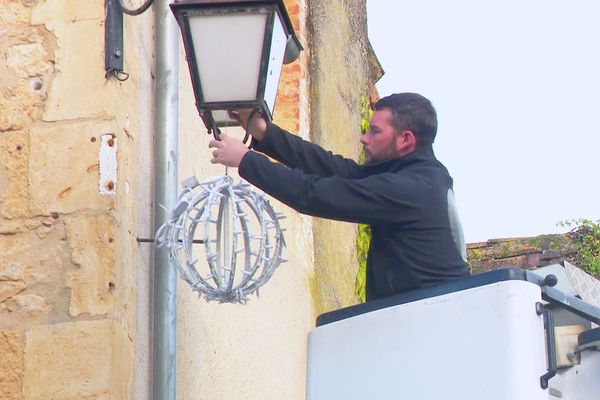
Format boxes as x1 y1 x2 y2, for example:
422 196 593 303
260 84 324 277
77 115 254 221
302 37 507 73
308 0 382 314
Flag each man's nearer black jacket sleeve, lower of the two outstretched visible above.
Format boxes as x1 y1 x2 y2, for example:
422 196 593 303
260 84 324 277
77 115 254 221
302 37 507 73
239 152 428 224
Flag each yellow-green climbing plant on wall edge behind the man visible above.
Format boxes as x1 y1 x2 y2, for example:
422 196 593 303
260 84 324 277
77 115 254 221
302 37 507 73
354 96 373 302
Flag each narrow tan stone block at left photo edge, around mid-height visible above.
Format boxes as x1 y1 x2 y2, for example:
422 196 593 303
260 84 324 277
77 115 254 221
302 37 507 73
0 131 29 218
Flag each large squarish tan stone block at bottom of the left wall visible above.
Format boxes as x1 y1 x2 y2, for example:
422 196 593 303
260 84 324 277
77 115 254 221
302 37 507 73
23 320 115 400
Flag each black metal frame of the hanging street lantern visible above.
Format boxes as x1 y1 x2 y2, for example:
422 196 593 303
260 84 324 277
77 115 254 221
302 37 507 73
170 0 303 132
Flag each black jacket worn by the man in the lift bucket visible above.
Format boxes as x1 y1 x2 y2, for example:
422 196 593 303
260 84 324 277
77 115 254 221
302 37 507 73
239 124 468 300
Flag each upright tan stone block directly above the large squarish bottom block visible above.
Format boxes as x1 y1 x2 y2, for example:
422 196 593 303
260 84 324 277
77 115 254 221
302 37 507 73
66 215 117 316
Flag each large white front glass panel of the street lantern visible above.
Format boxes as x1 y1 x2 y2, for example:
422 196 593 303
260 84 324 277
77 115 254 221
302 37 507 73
189 13 268 102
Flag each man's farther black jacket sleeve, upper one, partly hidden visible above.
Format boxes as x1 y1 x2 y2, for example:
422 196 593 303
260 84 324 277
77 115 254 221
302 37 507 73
253 123 361 178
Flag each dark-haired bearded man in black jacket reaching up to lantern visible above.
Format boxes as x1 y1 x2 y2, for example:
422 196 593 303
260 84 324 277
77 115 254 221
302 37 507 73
209 93 468 301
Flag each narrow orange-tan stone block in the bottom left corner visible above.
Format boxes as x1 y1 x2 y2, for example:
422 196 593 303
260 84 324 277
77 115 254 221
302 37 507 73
0 330 25 400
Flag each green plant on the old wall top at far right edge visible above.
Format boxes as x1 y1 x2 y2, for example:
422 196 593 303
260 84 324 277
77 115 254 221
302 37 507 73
558 219 600 278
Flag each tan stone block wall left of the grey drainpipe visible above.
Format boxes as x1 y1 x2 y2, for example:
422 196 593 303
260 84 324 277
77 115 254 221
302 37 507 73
0 0 153 400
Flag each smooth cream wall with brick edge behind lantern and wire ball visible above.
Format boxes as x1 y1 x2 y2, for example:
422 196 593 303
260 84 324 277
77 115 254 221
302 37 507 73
172 0 315 400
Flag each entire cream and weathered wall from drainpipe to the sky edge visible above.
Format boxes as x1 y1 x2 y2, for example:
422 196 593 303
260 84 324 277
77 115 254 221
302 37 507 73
177 0 380 399
